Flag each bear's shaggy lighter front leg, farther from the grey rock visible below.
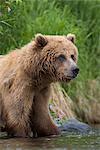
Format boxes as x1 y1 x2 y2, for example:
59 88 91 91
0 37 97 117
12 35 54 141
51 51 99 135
2 84 33 137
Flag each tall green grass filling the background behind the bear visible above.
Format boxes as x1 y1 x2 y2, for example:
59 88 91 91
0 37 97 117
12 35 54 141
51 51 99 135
0 0 100 121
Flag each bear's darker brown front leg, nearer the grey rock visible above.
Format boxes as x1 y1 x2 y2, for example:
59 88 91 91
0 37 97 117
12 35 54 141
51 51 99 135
30 88 60 137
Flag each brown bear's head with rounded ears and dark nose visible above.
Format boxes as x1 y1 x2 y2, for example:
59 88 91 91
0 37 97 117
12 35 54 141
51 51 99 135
35 34 79 82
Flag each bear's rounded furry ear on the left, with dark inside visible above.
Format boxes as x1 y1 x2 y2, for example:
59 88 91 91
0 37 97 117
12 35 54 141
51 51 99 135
35 34 48 47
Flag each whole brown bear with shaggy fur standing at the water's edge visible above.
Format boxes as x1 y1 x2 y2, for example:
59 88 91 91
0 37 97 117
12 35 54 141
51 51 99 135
0 34 79 137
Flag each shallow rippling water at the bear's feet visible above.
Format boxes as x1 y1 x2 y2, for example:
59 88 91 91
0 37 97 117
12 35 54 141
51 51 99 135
0 130 100 150
